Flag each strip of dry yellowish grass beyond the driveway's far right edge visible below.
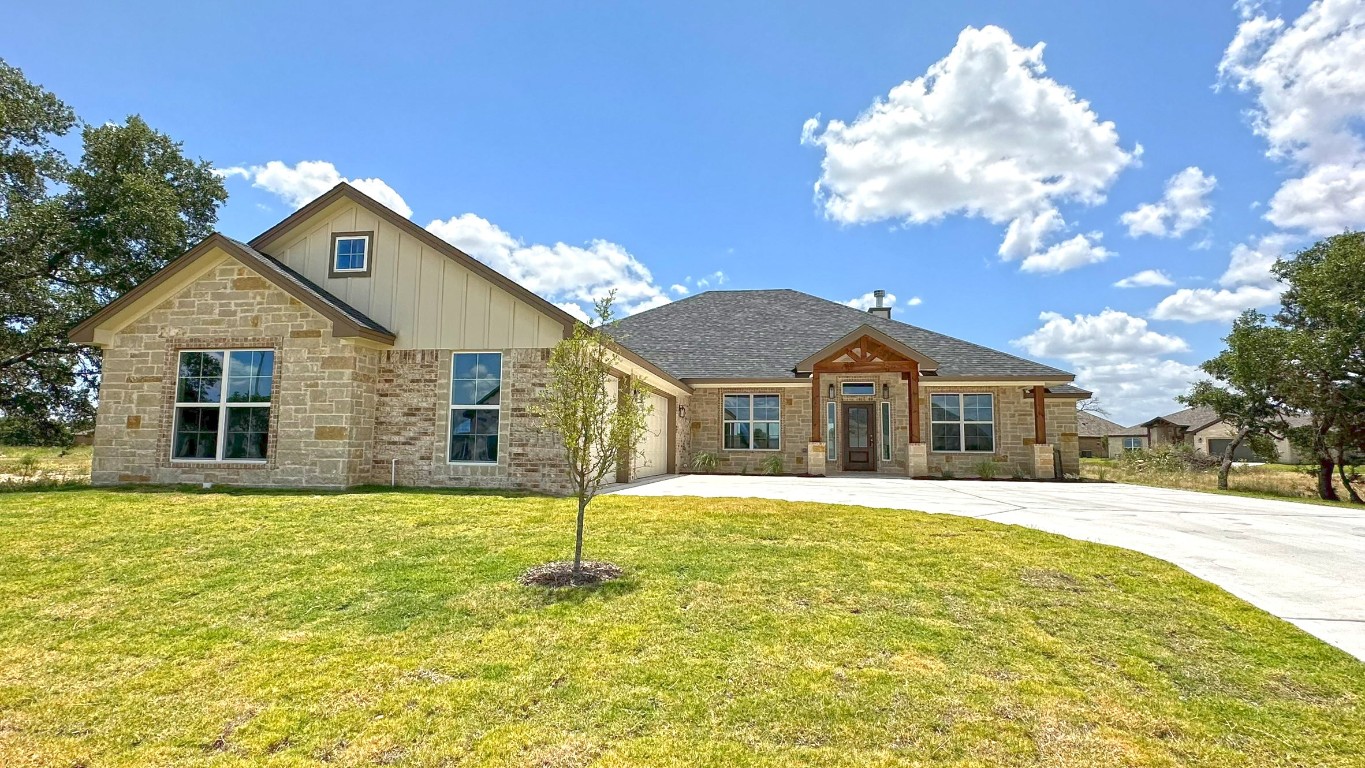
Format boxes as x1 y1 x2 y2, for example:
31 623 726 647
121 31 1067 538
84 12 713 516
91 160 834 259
1081 458 1365 509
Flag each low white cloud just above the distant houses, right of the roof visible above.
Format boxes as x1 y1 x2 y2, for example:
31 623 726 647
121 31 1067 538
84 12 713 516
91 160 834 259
1011 310 1201 424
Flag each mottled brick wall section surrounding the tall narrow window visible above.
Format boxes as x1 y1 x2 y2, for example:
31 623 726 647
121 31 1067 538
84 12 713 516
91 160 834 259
370 349 571 494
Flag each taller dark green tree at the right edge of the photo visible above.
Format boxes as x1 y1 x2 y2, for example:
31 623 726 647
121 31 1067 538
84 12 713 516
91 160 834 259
1275 232 1365 501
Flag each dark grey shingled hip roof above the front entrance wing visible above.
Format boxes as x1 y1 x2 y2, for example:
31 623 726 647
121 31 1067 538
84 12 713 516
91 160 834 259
610 289 1074 382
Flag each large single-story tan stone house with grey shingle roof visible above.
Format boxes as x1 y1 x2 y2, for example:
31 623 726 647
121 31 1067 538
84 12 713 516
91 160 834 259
71 184 1088 492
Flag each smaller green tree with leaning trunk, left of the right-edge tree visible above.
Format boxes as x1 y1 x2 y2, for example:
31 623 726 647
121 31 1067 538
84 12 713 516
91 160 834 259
1179 311 1290 490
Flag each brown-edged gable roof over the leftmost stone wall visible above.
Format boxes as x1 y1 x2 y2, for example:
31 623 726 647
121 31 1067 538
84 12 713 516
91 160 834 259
67 232 394 344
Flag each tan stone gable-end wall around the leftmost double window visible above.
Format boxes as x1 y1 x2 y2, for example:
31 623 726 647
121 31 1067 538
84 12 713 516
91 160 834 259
91 262 377 487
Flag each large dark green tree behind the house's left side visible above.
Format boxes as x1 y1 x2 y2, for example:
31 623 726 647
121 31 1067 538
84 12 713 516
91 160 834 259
0 60 227 439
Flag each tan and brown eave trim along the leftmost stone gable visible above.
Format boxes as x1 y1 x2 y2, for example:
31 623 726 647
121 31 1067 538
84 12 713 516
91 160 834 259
67 232 394 345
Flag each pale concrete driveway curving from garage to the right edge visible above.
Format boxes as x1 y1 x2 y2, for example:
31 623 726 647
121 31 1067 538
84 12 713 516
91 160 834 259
610 475 1365 660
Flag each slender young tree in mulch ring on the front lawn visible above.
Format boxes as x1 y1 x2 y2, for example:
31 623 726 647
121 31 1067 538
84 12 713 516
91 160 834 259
531 292 652 584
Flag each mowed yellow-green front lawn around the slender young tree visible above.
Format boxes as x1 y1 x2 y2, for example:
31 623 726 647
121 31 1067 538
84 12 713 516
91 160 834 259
0 490 1365 768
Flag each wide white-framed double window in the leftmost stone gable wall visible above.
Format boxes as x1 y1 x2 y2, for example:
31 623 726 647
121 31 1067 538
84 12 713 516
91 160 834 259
171 349 274 461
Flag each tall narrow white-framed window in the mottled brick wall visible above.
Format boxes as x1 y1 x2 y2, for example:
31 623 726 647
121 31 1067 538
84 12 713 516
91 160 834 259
450 352 502 464
